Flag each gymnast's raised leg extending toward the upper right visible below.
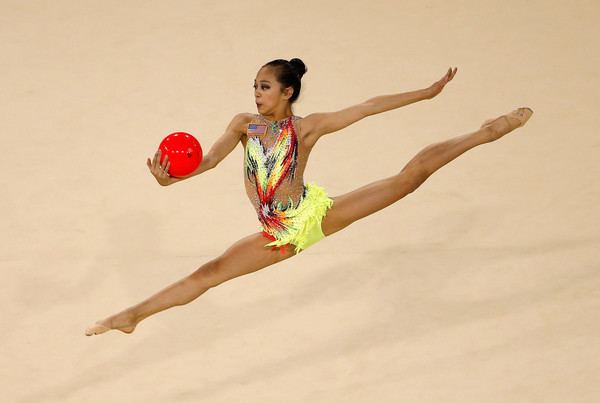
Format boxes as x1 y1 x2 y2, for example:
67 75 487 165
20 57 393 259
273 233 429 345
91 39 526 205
321 108 533 236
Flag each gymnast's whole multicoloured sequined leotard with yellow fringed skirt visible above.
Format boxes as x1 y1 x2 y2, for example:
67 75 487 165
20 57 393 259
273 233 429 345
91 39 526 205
244 115 333 253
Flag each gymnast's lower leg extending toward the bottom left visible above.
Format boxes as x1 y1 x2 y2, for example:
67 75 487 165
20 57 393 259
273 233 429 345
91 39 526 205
85 233 295 336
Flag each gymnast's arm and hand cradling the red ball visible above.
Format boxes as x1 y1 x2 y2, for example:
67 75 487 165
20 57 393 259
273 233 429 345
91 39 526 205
146 113 250 186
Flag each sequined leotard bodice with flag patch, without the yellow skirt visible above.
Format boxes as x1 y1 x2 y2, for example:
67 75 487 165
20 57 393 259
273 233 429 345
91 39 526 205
244 114 310 233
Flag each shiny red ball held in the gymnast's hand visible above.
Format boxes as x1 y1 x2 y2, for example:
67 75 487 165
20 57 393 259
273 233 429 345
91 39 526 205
158 132 202 177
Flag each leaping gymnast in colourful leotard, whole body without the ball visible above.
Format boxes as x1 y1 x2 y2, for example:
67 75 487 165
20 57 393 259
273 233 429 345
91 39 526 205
85 59 533 336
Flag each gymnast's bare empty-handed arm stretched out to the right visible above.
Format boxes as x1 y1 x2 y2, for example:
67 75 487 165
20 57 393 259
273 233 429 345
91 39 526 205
301 68 456 146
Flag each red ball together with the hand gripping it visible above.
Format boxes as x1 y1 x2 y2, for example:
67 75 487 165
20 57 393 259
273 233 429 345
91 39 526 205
146 132 202 186
